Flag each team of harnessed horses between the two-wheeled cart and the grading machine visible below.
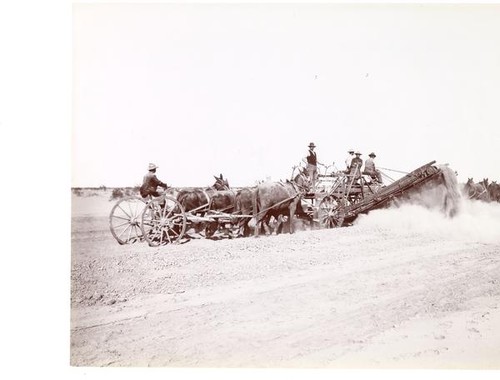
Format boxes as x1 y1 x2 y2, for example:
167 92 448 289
170 171 312 238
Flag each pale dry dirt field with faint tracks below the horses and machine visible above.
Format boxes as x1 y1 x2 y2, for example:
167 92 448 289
71 193 500 369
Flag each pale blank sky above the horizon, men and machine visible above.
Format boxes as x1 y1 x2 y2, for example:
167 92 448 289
72 4 500 186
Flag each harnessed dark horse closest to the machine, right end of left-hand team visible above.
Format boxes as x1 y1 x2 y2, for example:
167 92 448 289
248 171 311 235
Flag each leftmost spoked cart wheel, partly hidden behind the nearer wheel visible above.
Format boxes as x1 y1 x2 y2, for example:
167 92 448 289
109 197 146 244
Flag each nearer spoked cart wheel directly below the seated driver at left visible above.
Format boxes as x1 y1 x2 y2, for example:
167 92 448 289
141 196 187 247
